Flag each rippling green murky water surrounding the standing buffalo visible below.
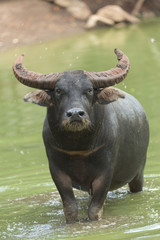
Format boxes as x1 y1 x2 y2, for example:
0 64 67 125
0 20 160 240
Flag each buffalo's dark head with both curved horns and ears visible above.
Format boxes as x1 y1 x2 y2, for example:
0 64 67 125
13 49 129 132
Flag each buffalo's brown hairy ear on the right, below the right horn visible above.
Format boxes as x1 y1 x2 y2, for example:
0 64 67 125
96 87 125 104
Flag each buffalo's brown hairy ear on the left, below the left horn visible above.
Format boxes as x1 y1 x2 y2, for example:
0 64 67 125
24 90 53 107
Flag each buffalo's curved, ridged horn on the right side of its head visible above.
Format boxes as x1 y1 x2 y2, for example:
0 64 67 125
85 48 129 88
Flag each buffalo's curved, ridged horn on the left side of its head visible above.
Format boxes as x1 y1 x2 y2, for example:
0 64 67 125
13 54 62 90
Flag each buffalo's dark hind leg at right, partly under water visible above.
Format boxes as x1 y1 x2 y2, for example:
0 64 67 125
129 171 143 193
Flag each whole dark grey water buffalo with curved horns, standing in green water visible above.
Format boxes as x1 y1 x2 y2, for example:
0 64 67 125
13 49 149 223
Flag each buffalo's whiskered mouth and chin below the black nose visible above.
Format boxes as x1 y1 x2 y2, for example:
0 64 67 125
62 119 91 132
